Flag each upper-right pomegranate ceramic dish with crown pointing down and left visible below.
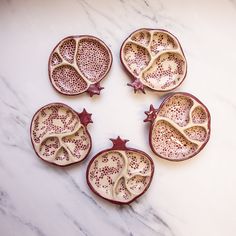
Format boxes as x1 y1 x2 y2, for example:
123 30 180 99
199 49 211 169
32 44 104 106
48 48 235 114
120 29 187 93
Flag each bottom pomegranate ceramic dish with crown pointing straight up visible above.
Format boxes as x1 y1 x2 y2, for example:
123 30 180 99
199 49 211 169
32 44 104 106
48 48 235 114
87 137 154 204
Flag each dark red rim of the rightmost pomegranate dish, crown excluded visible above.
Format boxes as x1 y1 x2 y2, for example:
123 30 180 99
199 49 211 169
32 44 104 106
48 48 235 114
145 92 211 162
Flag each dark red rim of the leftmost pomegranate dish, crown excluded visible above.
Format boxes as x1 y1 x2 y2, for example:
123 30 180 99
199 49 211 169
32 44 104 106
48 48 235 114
30 102 92 167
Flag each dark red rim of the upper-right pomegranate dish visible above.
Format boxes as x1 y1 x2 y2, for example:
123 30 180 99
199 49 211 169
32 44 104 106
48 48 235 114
120 28 188 93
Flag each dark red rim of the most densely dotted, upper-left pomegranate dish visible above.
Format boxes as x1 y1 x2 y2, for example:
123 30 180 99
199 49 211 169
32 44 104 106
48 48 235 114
48 34 113 97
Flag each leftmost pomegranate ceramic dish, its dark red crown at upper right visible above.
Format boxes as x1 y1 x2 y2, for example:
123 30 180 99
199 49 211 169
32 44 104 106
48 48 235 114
30 103 92 166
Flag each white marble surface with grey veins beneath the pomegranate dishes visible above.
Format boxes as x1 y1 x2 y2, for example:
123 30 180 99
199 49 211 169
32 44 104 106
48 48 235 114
0 0 236 236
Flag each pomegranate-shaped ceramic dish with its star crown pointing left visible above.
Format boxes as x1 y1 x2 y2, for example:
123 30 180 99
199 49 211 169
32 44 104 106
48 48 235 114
144 92 211 161
